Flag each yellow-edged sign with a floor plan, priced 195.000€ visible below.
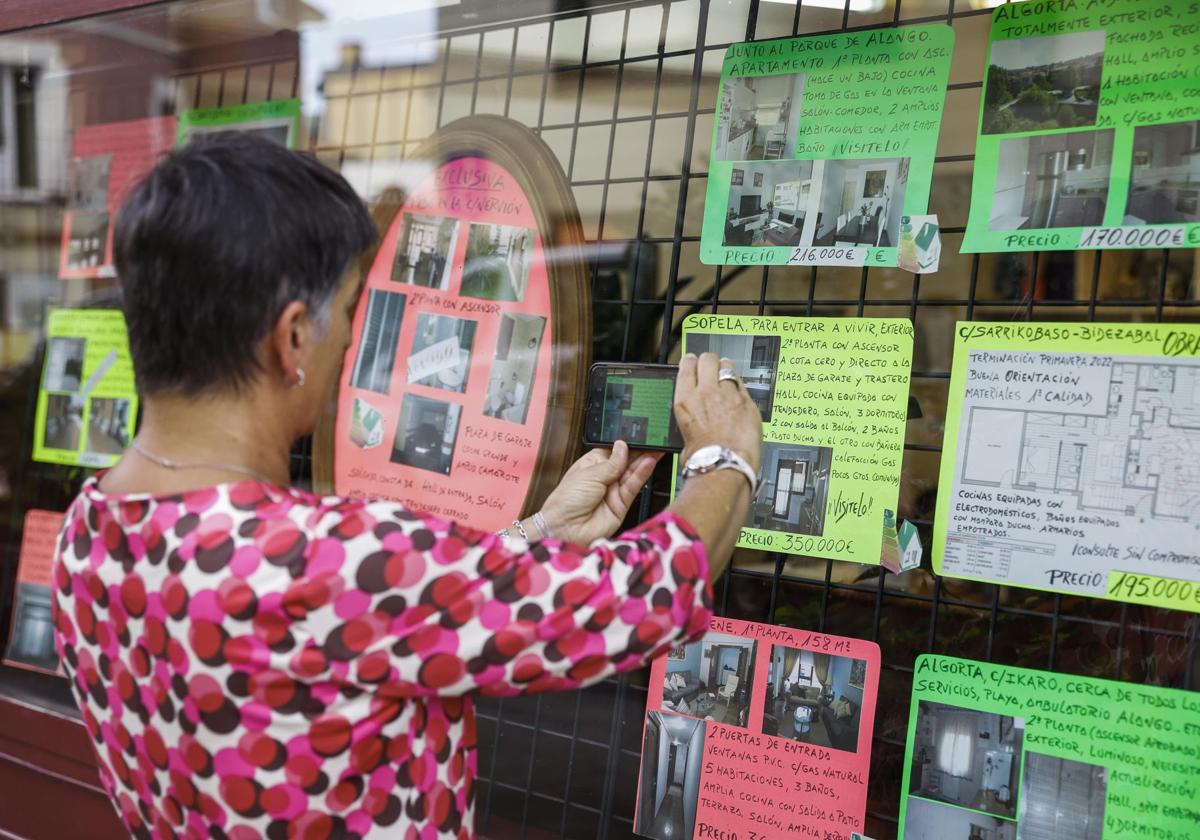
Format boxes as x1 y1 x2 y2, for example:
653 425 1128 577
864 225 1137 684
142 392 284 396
934 322 1200 612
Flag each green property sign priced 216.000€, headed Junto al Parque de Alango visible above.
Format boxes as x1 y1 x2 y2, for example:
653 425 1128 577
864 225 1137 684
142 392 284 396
700 24 954 265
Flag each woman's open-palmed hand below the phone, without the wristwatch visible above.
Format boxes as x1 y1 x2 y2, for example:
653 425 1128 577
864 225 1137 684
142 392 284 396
541 440 662 545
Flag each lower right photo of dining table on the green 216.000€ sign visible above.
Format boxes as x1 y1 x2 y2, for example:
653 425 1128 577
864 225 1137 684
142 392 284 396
812 157 908 248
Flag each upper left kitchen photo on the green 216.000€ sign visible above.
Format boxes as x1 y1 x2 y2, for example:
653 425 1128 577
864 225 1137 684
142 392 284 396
714 73 804 161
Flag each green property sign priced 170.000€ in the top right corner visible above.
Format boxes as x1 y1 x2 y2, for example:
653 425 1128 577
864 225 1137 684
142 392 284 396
962 0 1200 252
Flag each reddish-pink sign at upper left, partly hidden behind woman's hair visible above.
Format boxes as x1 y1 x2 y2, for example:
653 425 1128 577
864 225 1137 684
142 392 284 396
59 116 175 280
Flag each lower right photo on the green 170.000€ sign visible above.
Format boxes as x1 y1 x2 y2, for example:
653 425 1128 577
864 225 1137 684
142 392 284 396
1124 120 1200 224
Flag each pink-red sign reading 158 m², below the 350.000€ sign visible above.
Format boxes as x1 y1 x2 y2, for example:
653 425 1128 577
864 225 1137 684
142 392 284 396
634 618 880 840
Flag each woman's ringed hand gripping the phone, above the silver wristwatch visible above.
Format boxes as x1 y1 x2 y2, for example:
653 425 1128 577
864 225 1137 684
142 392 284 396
674 353 762 472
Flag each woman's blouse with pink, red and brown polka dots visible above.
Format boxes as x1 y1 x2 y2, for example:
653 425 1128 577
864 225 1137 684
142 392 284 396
54 479 712 840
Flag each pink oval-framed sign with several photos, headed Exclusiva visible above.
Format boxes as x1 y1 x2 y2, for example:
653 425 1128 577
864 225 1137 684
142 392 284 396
334 157 553 529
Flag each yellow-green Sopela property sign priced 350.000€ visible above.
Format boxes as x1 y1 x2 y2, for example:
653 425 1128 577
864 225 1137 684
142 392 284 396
676 314 912 565
